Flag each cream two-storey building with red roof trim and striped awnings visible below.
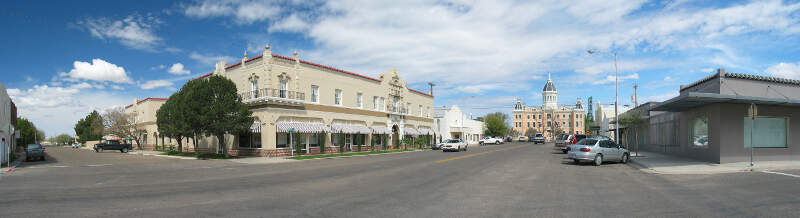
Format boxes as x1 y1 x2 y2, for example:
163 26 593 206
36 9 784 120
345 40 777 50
191 41 433 156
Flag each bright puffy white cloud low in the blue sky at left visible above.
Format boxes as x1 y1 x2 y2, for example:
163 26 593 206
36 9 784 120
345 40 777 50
64 58 132 83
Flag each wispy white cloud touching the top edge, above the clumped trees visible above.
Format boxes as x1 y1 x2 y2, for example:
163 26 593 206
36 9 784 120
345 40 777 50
184 0 281 24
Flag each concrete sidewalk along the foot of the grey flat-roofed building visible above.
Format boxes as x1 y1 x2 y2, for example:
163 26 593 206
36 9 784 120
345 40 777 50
631 151 800 174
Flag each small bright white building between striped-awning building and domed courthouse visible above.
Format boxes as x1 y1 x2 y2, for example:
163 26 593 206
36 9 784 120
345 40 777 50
433 105 484 144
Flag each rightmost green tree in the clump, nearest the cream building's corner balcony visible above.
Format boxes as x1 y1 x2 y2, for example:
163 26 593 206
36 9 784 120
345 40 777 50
197 75 254 157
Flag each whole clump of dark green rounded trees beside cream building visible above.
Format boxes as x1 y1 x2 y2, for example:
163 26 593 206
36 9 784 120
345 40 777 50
156 75 253 156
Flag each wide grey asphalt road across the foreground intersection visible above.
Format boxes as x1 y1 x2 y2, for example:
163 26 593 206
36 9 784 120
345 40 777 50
0 143 800 217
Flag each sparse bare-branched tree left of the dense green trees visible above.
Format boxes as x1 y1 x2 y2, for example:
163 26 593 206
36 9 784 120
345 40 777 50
102 107 144 150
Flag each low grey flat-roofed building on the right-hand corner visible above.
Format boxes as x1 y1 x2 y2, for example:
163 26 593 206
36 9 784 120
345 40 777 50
621 69 800 163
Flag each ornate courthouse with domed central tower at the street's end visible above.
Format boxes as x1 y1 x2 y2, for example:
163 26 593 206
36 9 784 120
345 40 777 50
512 74 586 140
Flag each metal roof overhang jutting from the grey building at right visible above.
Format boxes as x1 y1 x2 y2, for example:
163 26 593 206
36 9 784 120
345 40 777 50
650 92 800 112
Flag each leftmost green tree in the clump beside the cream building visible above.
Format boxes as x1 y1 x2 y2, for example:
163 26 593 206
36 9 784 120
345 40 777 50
156 91 192 151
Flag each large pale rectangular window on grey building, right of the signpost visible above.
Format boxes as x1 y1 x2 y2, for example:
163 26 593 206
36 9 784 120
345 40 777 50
744 117 789 148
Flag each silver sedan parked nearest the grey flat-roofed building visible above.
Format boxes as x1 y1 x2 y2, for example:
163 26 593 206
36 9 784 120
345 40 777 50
567 137 630 166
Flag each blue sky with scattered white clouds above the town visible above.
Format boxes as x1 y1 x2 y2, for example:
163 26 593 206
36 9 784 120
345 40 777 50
0 0 800 136
